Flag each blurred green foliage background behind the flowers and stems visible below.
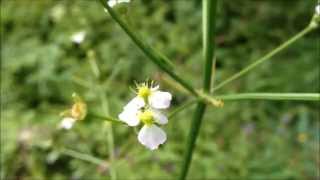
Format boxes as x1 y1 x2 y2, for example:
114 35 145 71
1 0 320 180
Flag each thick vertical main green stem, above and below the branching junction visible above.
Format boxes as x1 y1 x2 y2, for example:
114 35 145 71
179 0 217 180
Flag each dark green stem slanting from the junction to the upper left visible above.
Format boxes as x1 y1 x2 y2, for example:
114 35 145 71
100 0 198 96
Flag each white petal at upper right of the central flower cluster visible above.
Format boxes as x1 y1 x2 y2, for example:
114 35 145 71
149 91 172 109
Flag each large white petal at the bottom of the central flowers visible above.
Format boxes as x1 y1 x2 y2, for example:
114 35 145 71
138 125 167 150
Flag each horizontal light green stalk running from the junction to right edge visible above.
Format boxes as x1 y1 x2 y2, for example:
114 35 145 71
216 93 320 101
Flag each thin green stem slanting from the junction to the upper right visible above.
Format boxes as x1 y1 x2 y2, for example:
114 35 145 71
212 26 315 91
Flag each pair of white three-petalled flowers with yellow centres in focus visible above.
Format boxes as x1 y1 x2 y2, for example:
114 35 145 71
119 83 172 150
